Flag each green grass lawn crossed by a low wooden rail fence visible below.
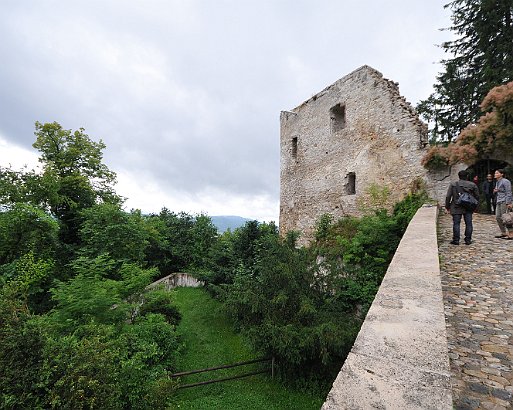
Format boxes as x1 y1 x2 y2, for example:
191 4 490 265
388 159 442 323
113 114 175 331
172 288 324 410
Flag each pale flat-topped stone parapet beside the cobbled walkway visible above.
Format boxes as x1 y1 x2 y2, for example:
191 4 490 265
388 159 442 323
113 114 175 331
322 206 452 410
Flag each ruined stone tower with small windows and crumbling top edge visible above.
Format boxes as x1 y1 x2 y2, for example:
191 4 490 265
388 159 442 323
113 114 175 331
280 66 440 243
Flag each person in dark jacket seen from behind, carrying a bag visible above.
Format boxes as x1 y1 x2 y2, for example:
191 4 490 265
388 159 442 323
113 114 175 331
445 171 479 245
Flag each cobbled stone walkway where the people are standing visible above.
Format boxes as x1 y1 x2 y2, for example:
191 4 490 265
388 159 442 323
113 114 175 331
438 214 513 410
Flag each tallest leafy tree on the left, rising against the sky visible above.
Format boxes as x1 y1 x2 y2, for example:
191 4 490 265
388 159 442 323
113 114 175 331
0 122 122 244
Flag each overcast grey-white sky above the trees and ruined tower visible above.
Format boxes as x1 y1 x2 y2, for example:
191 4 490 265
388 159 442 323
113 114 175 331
0 0 450 221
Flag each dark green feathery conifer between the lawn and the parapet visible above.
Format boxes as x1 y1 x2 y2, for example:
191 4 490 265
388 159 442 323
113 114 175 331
226 235 359 380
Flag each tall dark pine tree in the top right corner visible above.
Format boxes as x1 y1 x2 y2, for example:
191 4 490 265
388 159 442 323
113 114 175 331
417 0 513 142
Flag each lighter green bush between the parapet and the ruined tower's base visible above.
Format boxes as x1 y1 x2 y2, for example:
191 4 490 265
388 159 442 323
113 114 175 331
312 190 427 314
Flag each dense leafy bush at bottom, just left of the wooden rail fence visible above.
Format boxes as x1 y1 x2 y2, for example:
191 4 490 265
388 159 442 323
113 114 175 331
41 315 179 409
